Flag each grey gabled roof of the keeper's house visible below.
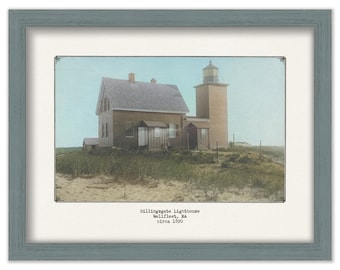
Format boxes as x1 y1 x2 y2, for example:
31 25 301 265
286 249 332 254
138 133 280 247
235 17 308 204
96 78 189 114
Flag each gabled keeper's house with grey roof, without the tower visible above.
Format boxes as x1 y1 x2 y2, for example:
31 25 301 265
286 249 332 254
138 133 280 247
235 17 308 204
96 73 189 149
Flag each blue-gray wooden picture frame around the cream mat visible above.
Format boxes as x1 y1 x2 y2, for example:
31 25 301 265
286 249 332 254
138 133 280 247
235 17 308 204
9 10 332 260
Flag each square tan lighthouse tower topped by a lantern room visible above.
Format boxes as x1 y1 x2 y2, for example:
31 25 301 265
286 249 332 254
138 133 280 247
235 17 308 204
195 61 228 149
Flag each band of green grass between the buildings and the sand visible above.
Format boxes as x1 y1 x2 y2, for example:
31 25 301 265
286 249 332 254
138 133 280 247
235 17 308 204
56 147 284 201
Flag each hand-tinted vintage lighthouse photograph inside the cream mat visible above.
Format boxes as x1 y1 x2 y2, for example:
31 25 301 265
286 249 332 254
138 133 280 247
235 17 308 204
54 56 286 203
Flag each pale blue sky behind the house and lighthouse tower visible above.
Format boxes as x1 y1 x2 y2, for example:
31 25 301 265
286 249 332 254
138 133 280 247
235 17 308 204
55 57 285 147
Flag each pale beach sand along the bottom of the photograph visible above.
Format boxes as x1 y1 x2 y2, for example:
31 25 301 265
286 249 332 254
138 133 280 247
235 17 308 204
55 174 282 202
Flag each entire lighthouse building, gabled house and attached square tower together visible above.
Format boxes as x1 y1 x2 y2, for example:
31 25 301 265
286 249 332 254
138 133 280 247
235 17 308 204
84 62 228 150
